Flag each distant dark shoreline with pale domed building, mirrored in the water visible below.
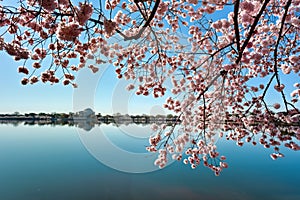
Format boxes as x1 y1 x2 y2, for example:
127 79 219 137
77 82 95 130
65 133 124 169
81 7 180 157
0 108 177 131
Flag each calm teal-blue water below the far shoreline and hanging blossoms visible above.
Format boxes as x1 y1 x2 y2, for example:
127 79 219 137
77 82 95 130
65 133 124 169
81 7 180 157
0 125 300 200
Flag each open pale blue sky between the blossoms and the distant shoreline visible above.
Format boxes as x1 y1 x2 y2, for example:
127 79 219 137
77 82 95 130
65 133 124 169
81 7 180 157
0 49 169 114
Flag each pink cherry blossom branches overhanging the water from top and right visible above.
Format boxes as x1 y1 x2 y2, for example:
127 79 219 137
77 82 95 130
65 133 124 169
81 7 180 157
0 0 300 175
